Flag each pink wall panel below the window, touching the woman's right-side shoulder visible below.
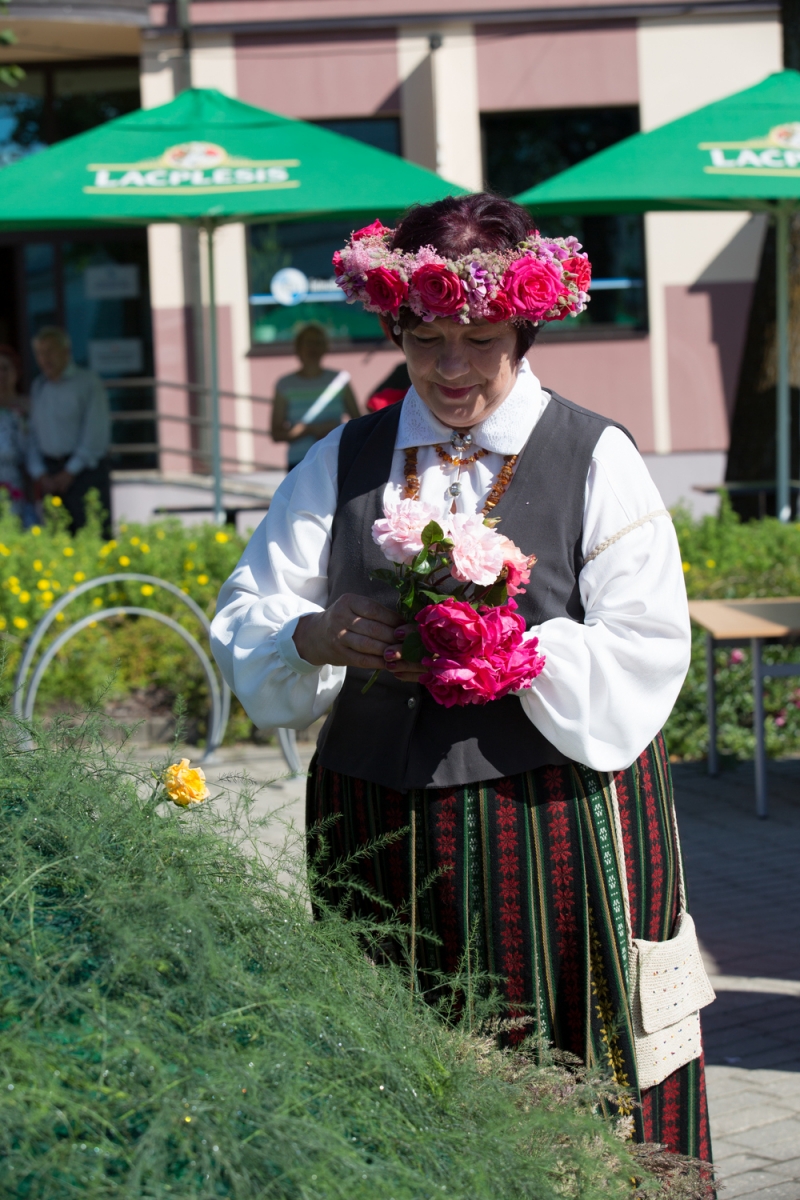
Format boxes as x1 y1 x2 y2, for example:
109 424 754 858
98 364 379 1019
528 337 654 452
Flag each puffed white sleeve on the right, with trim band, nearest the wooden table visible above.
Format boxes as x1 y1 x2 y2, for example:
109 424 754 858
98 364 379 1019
518 427 691 770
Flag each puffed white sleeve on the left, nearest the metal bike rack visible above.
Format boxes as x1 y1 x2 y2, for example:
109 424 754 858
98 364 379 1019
211 426 345 730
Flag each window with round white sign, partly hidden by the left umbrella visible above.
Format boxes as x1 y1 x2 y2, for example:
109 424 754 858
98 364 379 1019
247 116 401 350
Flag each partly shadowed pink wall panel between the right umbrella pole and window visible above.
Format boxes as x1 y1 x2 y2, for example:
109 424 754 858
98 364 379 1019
664 283 753 450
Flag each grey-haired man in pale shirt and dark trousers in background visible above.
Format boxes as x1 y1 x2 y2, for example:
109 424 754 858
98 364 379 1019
28 325 112 536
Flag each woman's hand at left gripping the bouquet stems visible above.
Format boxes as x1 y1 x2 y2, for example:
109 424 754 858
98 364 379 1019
294 593 403 671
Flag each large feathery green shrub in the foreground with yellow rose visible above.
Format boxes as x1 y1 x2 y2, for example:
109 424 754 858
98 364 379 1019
0 720 657 1200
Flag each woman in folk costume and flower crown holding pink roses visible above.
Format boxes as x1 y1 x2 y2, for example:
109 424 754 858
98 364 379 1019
212 194 712 1159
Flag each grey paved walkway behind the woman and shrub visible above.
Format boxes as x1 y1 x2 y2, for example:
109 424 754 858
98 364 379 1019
143 743 800 1200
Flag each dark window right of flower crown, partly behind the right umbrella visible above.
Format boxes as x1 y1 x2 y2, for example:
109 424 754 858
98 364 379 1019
481 107 646 337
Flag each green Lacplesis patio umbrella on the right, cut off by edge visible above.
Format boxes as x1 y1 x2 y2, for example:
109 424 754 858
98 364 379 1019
515 71 800 521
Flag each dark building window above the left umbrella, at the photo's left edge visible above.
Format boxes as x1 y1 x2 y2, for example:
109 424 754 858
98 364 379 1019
0 59 139 167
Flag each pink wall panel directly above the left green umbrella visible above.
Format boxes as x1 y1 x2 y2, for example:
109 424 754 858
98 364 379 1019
236 32 399 119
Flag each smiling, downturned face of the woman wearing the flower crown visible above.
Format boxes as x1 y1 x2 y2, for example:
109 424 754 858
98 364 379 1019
403 317 519 428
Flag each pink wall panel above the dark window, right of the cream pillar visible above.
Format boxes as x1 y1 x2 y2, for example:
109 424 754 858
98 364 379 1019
476 23 639 113
